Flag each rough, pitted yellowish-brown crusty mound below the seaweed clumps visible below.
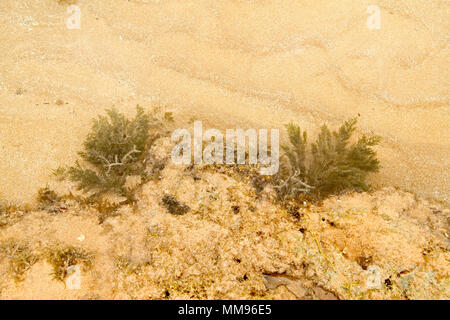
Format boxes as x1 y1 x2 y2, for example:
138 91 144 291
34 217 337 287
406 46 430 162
0 139 450 299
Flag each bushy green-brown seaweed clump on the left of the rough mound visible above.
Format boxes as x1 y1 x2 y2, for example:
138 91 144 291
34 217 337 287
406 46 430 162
55 106 159 198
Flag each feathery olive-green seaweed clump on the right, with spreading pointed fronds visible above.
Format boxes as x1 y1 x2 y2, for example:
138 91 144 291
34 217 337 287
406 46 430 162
274 118 380 202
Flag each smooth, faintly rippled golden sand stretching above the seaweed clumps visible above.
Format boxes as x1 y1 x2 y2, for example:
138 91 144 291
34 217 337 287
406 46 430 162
0 0 450 203
